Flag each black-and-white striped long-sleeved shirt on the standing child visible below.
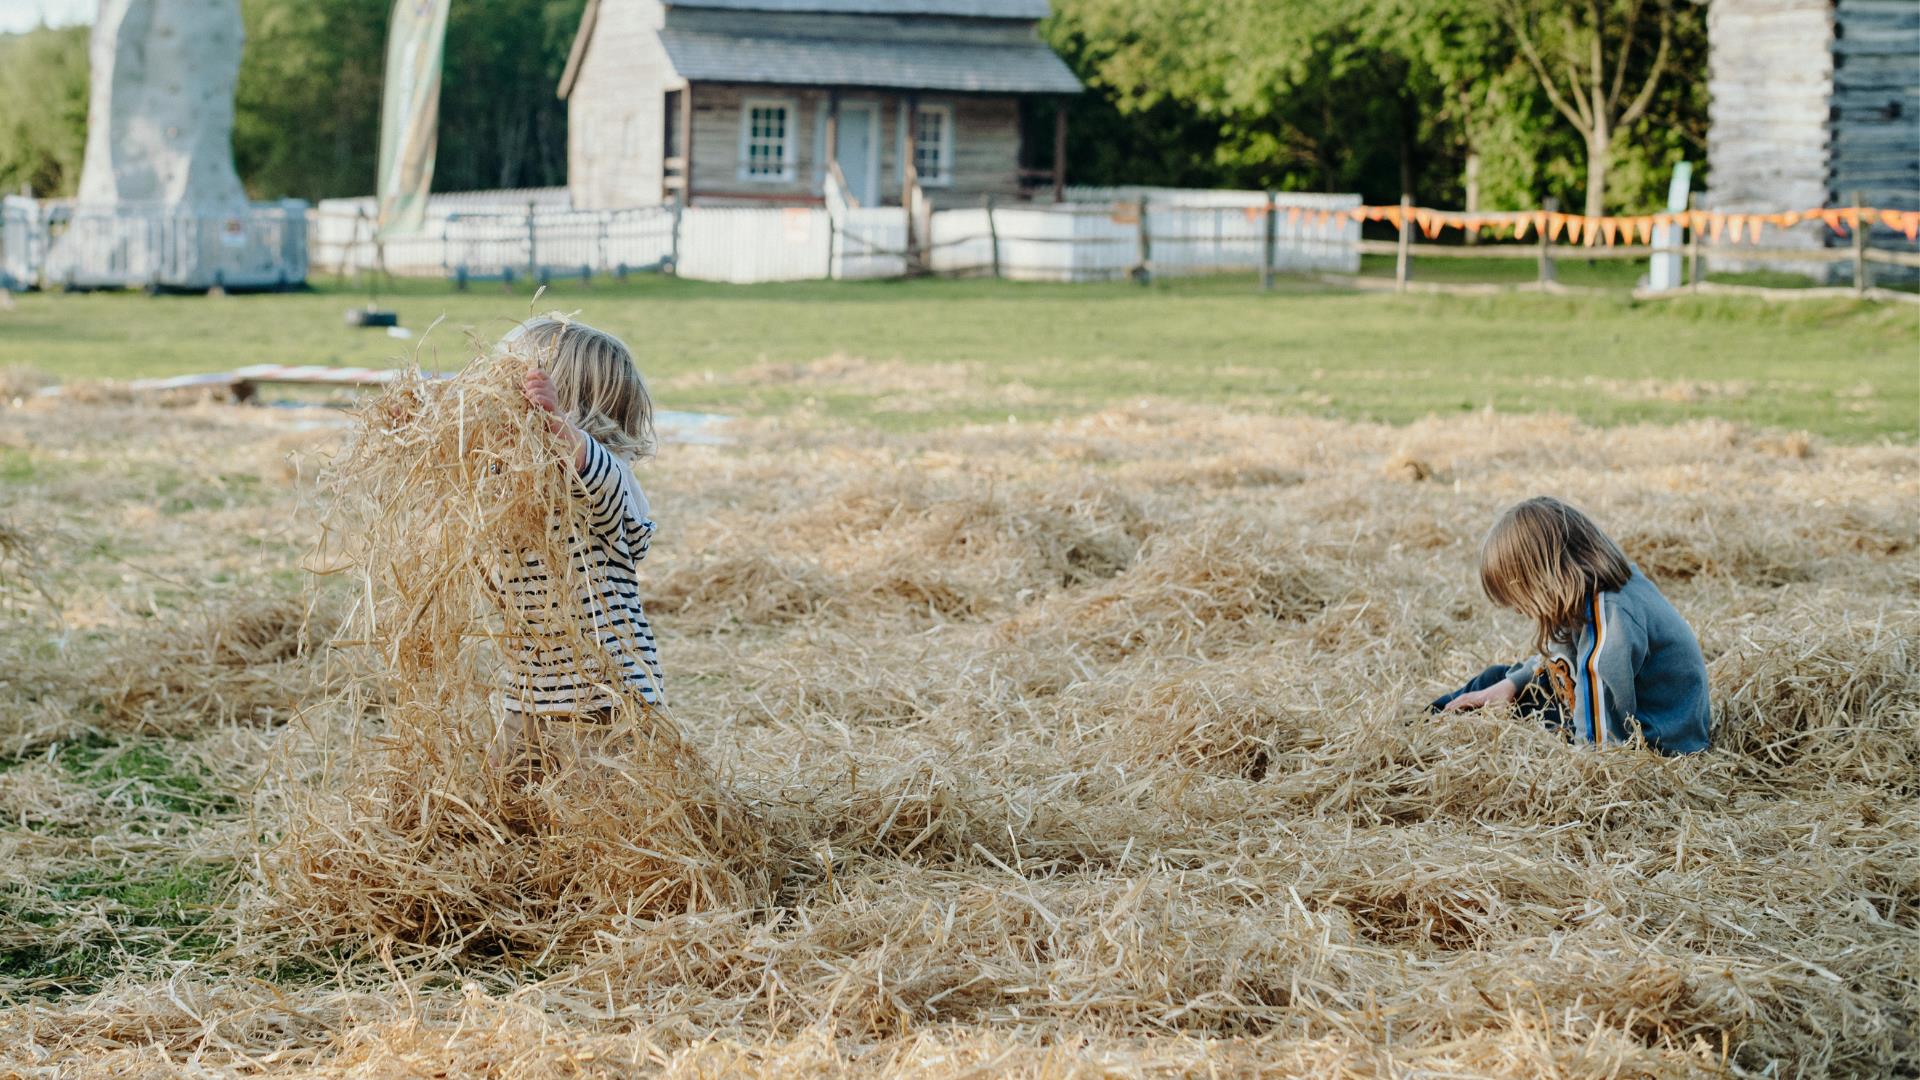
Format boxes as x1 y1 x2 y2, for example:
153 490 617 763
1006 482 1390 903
501 436 664 715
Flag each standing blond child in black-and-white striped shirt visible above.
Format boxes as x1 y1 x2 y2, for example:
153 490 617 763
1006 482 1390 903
499 317 664 744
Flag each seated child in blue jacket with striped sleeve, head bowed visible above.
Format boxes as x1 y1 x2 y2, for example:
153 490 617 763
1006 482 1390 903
1428 496 1713 753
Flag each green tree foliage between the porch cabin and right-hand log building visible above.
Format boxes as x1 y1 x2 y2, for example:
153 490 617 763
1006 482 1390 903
1044 0 1707 209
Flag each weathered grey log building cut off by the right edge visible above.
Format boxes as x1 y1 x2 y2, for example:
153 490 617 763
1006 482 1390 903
1707 0 1920 277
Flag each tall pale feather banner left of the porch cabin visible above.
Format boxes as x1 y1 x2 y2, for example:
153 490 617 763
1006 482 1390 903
374 0 451 240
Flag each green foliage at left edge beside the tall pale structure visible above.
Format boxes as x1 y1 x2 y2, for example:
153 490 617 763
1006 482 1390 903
0 27 86 196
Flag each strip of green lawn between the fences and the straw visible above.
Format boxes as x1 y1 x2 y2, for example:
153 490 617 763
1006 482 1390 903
0 272 1920 442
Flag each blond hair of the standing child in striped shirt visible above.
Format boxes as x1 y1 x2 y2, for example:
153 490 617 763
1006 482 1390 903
499 313 655 459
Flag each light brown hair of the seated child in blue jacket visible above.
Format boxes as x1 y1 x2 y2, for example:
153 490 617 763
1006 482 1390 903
1480 496 1634 653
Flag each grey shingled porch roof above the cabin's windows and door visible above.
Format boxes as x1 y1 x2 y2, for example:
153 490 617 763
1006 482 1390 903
660 29 1081 94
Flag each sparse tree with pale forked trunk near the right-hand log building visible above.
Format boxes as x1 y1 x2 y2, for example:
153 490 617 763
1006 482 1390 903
1496 0 1674 217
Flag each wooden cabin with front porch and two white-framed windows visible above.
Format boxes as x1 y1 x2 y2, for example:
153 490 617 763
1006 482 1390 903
559 0 1081 209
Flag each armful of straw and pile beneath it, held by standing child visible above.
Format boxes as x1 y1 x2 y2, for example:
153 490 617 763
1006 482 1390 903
269 343 766 957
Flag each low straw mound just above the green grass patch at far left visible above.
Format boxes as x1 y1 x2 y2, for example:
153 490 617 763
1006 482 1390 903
94 594 344 736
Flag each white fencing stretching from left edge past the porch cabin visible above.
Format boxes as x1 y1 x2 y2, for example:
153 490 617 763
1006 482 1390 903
0 188 1359 288
